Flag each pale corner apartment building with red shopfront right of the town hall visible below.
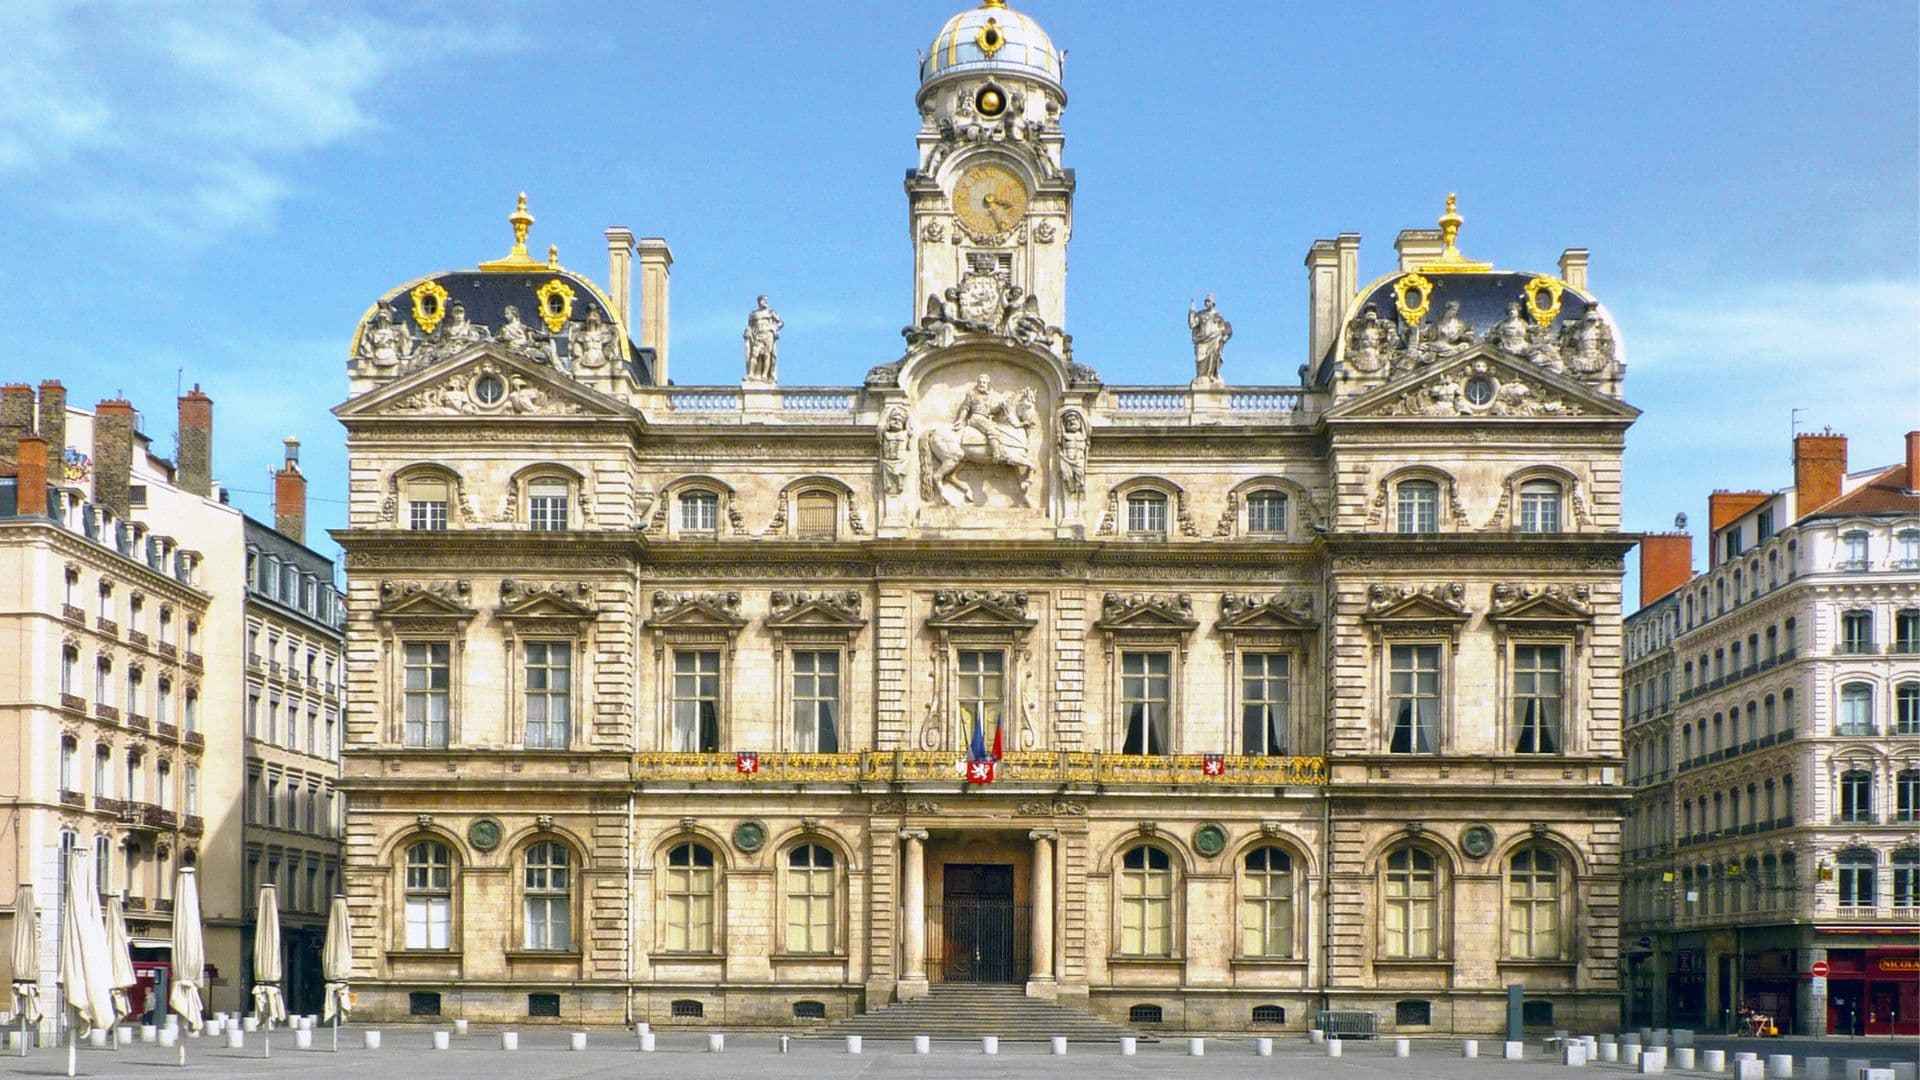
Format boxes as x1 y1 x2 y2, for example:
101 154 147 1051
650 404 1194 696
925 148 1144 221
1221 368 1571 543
1622 432 1920 1034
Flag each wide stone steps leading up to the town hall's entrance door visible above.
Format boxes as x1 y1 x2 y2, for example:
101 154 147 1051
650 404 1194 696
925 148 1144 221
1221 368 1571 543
808 982 1154 1042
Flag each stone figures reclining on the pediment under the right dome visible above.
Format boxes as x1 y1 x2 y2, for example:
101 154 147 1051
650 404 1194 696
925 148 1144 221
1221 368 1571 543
1346 300 1615 382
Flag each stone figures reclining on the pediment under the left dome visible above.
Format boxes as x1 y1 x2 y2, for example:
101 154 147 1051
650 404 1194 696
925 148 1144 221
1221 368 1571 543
355 302 620 375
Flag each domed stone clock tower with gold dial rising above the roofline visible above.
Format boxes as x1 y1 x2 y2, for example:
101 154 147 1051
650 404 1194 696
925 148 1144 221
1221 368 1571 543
906 0 1073 327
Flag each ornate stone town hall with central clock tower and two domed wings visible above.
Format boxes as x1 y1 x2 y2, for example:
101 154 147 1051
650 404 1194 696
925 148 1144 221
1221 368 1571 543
336 0 1636 1032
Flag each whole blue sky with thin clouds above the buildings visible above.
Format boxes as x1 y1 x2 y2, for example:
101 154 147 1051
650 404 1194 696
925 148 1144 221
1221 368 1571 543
0 0 1920 595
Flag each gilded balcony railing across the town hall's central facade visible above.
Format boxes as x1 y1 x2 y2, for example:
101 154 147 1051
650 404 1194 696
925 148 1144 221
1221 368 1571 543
632 751 1327 788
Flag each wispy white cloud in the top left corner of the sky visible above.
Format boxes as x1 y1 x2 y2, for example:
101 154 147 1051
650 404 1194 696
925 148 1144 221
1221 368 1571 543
0 0 497 242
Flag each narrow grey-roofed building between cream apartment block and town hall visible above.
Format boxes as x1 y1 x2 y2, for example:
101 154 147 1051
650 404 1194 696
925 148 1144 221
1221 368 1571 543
244 438 346 1013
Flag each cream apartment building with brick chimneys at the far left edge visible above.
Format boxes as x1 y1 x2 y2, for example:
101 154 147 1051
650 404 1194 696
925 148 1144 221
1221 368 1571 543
0 382 345 1011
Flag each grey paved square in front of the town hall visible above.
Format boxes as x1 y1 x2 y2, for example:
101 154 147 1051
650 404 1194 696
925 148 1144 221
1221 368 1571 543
0 1026 1912 1080
